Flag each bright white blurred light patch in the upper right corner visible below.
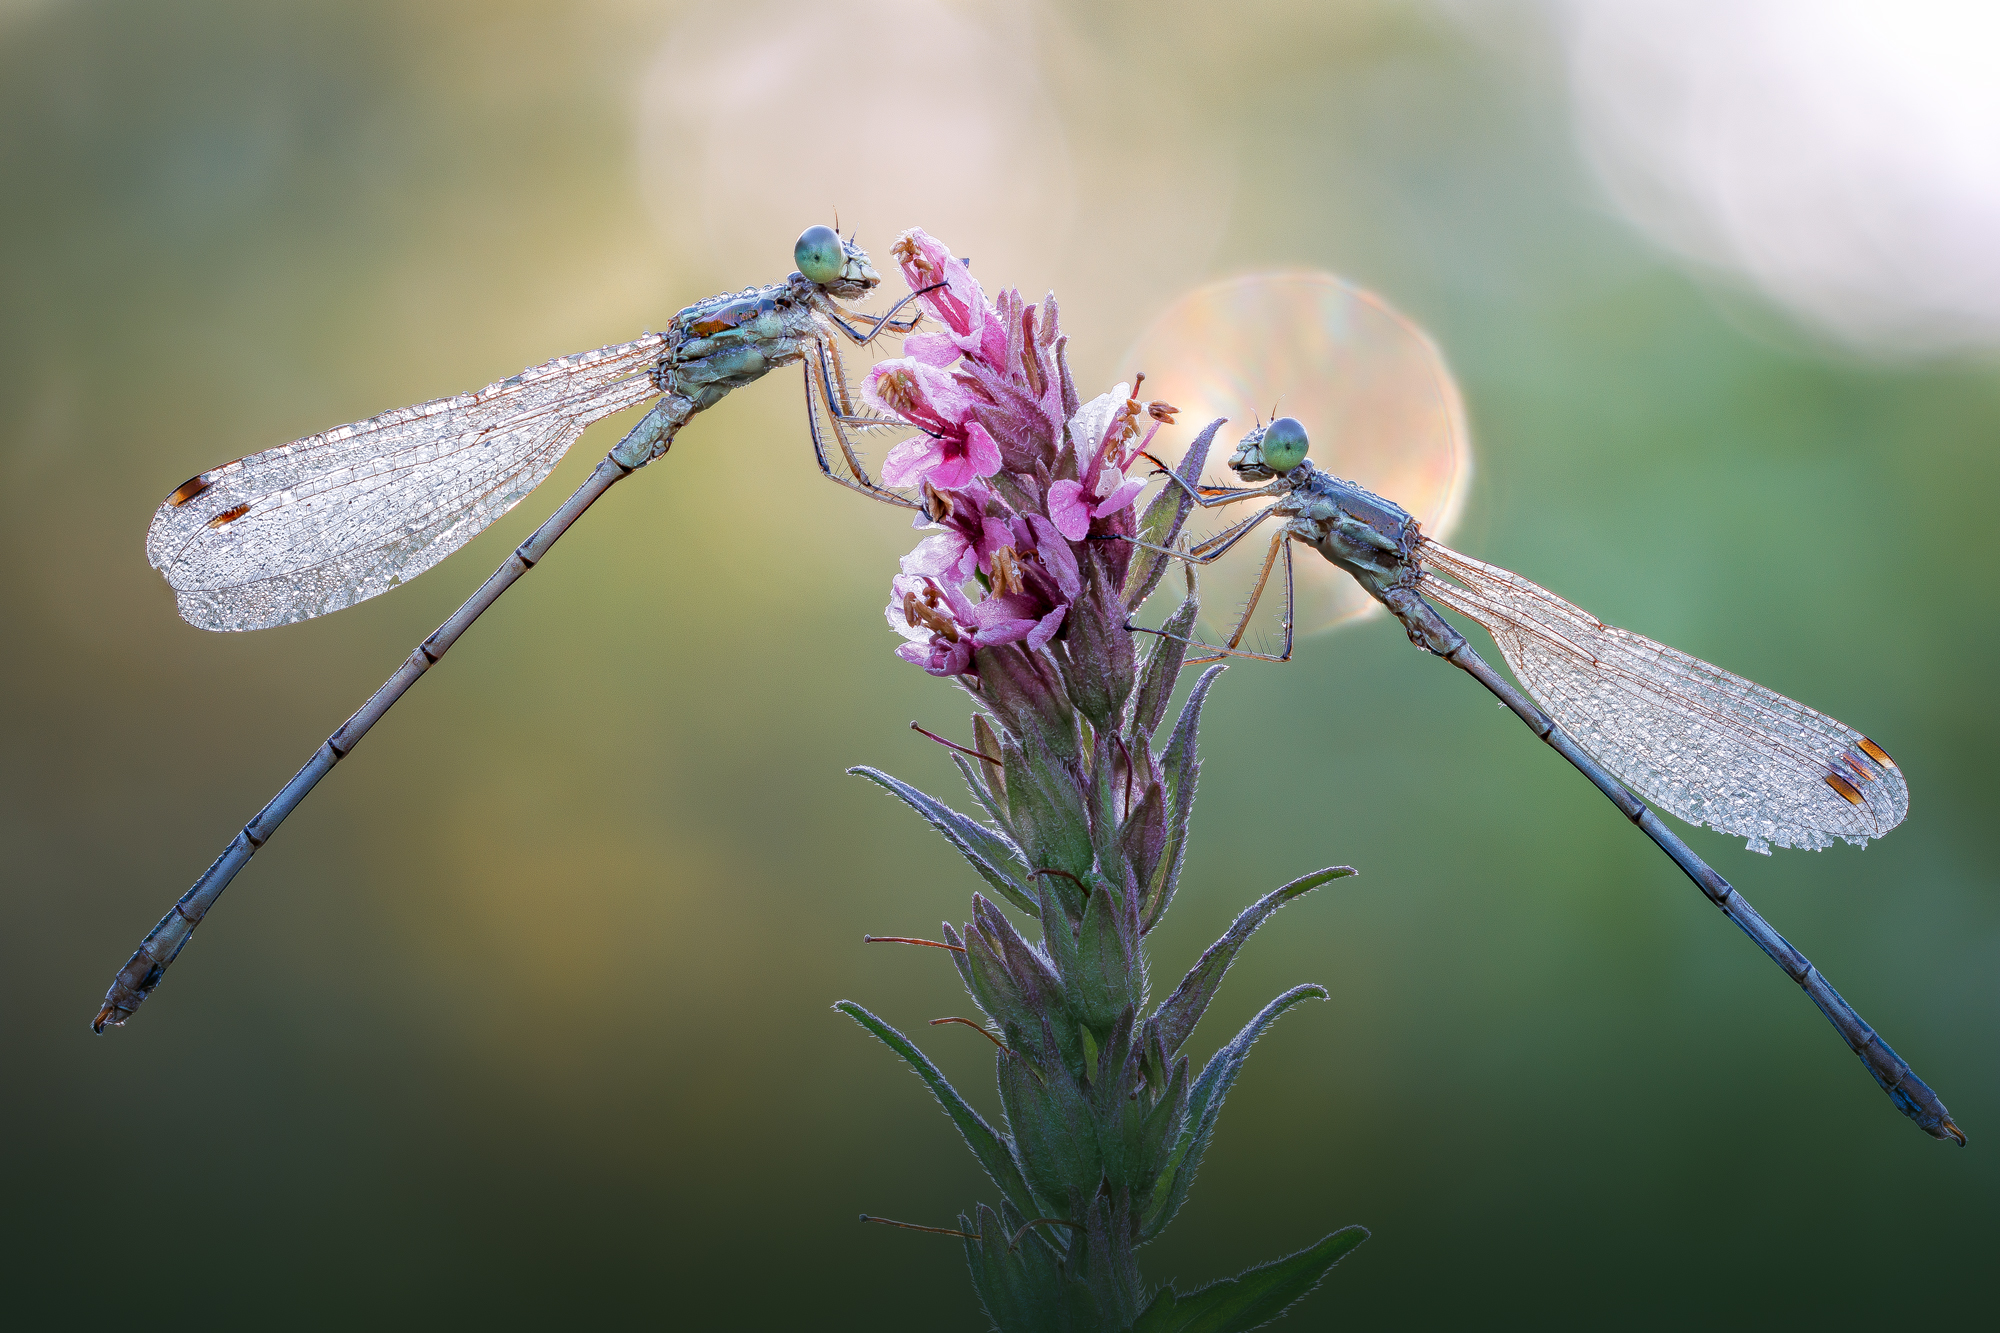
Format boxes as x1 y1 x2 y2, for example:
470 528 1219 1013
1558 0 2000 354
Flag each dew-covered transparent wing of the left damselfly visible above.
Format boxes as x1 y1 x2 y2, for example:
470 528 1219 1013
146 334 666 630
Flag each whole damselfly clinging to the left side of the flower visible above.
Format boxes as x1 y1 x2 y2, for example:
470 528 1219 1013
92 226 928 1031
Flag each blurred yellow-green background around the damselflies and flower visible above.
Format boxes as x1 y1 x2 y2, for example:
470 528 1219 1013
0 0 2000 1329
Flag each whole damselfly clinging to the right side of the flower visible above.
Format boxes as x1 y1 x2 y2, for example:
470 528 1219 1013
1142 274 1964 1145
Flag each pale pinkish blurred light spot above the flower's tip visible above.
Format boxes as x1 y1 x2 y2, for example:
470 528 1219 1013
638 0 1074 286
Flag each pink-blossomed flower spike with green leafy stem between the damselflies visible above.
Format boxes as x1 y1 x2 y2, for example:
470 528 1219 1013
838 230 1366 1333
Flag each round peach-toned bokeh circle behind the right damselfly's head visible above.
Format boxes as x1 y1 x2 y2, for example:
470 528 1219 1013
1118 272 1472 648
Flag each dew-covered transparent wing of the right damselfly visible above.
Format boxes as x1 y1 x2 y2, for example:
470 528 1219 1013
1418 538 1910 851
